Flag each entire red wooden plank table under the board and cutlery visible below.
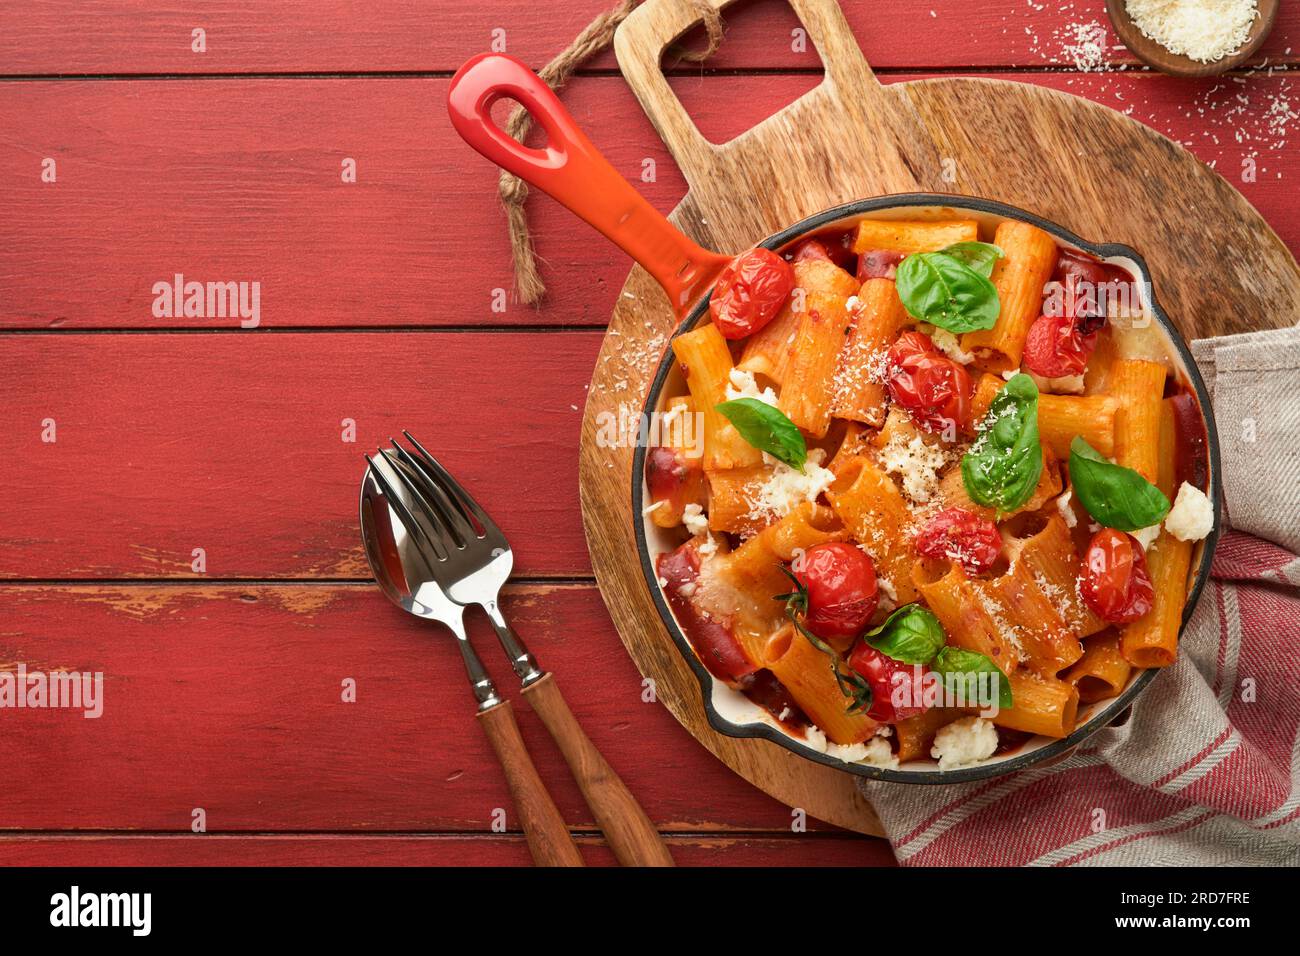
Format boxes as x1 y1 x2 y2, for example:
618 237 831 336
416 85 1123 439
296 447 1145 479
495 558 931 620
0 0 1300 864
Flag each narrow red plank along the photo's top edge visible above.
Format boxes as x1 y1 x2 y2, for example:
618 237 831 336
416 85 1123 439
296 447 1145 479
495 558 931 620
0 0 1300 75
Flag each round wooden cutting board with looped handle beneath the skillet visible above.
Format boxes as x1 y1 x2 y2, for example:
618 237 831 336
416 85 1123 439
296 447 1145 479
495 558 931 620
580 0 1300 834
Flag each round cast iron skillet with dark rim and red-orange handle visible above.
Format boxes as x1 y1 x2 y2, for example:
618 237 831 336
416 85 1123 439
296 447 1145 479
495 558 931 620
447 53 1219 784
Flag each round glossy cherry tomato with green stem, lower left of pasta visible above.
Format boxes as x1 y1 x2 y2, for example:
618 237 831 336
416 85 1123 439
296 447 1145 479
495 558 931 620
794 541 880 640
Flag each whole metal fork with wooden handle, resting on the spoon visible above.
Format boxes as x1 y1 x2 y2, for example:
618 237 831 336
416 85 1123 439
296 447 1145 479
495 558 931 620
366 431 673 866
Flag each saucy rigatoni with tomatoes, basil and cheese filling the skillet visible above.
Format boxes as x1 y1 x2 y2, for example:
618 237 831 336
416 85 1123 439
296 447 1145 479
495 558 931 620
646 208 1199 770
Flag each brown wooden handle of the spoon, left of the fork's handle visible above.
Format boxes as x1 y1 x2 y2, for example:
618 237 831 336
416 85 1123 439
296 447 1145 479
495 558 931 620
478 701 585 866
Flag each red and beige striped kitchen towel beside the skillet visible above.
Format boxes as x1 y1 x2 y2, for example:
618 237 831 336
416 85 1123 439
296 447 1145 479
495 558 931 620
861 326 1300 866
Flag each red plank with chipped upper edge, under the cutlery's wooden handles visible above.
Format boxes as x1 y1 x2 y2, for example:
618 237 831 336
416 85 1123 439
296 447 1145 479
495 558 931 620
0 585 863 832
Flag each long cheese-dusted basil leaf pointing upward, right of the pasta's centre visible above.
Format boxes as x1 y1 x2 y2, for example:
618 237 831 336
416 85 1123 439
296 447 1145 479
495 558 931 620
962 372 1043 516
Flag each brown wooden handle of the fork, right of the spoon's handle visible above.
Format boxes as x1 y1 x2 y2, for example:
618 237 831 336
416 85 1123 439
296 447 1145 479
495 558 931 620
524 674 673 866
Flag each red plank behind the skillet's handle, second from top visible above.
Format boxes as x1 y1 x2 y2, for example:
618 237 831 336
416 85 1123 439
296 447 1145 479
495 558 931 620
0 73 1300 328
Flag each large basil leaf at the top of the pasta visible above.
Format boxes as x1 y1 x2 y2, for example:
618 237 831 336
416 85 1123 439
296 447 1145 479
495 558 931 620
894 252 1001 333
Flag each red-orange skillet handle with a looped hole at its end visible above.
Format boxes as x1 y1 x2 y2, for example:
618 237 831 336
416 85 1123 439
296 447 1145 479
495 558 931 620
447 53 729 316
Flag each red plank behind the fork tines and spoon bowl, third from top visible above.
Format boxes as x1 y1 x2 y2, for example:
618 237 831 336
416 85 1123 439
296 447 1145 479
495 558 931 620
0 332 616 579
